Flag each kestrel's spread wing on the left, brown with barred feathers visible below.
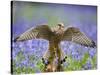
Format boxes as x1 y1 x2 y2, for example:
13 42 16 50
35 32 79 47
14 25 52 42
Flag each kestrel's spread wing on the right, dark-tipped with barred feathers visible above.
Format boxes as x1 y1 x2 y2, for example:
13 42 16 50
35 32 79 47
62 27 96 47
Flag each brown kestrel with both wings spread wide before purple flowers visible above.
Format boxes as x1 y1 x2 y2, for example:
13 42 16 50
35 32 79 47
14 23 96 71
